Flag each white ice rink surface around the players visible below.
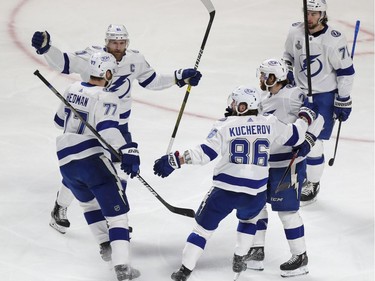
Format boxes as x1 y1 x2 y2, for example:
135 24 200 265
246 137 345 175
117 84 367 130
0 0 374 281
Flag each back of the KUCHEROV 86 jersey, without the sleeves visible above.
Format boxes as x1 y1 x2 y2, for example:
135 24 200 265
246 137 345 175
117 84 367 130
212 115 291 194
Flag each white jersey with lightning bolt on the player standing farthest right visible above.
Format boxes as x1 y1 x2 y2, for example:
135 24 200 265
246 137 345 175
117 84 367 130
284 23 355 97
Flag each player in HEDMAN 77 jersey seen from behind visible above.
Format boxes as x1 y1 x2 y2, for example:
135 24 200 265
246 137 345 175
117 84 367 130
56 52 140 281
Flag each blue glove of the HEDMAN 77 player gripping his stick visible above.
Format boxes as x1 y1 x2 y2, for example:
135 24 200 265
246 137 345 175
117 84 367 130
120 142 140 178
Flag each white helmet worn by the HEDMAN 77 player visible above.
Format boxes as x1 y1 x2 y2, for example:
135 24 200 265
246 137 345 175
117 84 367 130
90 52 117 79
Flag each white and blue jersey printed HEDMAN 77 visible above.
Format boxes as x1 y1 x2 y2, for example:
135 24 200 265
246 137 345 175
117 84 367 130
55 82 126 166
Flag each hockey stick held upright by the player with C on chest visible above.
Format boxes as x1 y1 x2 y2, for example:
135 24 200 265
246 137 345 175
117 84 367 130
167 0 215 154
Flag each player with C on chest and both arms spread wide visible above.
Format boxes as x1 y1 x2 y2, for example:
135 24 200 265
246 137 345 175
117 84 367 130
31 24 202 233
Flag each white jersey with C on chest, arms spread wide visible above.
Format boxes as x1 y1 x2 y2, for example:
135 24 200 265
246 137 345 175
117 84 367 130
44 46 176 124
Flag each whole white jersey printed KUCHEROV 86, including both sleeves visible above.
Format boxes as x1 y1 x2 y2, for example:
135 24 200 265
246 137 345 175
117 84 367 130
188 115 308 195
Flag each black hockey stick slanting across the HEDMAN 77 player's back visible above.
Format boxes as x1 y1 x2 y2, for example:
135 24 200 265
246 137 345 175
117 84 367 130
34 70 195 218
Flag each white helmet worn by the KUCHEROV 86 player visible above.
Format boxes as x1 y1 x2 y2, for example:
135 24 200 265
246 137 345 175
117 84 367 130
229 86 260 115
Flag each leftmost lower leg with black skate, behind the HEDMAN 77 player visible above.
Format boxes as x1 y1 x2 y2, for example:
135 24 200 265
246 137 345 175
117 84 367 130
49 183 74 234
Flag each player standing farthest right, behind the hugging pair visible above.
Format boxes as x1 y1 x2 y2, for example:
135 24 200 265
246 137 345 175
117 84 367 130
284 0 354 205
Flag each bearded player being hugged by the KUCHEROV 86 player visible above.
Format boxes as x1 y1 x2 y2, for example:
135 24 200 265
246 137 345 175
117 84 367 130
245 59 324 277
